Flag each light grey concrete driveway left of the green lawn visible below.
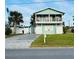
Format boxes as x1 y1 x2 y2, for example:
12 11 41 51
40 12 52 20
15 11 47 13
5 34 39 49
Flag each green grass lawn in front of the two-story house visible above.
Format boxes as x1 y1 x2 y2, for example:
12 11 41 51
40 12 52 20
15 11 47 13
31 33 74 47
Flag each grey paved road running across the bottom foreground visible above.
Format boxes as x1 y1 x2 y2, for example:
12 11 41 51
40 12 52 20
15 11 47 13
5 48 74 59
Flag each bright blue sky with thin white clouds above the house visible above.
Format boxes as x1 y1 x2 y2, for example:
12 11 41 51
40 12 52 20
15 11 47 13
5 0 74 26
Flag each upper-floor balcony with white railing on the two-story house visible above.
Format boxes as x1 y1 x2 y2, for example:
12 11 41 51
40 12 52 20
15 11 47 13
35 16 63 24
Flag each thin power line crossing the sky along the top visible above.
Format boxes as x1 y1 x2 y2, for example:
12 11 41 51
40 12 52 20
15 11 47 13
6 0 73 5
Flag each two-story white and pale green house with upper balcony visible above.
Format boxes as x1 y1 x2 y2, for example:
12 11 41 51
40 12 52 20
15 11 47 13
31 8 64 34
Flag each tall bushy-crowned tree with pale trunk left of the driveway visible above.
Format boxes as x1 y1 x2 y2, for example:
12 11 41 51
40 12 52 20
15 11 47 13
8 11 23 34
